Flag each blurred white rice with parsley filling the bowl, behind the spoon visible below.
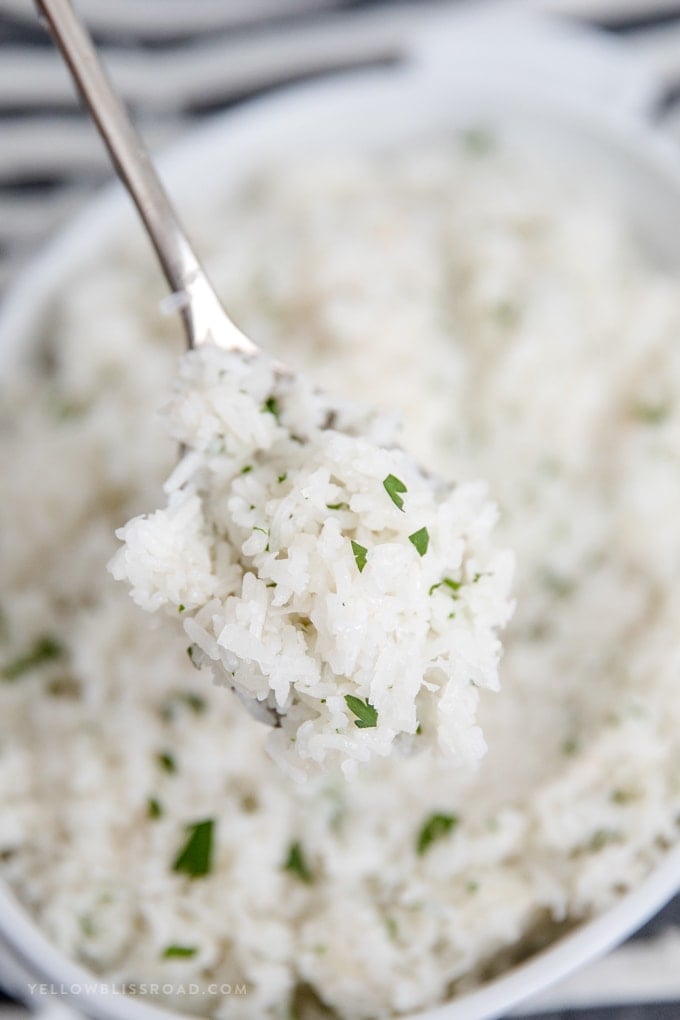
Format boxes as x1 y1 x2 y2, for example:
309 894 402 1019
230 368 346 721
0 137 680 1020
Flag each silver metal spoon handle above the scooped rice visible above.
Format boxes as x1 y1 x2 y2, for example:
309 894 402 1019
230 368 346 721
36 0 257 353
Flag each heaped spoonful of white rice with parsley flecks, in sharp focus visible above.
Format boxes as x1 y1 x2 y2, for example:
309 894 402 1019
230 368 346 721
110 347 512 779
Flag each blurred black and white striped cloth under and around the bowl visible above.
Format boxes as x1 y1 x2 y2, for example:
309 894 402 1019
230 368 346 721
0 0 680 1020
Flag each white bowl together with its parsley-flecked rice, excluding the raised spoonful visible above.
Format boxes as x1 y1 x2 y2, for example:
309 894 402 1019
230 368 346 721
0 7 680 1020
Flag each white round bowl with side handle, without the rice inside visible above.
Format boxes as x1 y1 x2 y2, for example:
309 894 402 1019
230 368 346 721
0 13 680 1020
